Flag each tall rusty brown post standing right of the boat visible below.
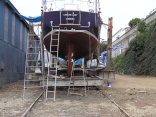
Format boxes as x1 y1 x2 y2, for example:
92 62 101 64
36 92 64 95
106 17 113 70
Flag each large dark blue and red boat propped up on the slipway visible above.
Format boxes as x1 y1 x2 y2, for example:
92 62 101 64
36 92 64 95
42 0 99 75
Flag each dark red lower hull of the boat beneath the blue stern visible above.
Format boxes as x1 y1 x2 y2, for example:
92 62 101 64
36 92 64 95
43 30 98 60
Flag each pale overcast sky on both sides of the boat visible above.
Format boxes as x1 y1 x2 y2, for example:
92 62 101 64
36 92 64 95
10 0 156 40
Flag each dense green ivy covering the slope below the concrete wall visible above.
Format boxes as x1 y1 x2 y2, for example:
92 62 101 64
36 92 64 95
112 21 156 76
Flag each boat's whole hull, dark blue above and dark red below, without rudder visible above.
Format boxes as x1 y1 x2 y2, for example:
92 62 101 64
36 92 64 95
42 11 98 59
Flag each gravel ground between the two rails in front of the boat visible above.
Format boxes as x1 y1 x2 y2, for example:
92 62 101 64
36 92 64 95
28 90 125 117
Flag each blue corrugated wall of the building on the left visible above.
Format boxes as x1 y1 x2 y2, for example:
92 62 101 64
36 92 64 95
0 0 28 86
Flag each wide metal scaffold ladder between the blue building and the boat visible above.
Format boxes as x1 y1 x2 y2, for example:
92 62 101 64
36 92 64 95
23 24 44 99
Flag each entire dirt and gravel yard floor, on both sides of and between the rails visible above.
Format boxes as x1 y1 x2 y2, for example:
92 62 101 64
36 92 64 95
0 74 156 117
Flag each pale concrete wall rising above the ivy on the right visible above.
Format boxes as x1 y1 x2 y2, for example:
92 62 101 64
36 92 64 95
112 11 156 57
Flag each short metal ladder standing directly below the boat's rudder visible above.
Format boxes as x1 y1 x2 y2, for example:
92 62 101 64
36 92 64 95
67 59 86 97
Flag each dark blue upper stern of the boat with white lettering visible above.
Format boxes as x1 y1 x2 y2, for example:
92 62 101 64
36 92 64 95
42 11 98 37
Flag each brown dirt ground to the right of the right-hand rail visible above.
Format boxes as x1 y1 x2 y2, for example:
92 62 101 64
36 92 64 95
103 74 156 117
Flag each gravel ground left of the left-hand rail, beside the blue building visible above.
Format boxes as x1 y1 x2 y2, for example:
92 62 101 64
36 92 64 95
0 81 42 117
